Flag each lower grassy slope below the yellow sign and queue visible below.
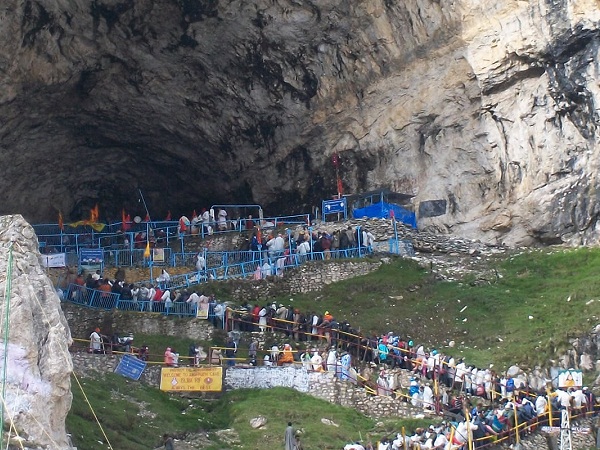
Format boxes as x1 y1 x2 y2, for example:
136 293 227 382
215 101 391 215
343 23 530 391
67 374 428 450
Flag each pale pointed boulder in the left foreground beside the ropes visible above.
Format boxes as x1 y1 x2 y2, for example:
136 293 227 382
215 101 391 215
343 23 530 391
0 215 73 450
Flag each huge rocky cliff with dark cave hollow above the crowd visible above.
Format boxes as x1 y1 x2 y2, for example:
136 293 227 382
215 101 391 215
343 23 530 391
0 0 600 244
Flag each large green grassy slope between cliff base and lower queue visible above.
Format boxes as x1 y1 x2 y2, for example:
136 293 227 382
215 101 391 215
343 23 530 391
260 249 600 367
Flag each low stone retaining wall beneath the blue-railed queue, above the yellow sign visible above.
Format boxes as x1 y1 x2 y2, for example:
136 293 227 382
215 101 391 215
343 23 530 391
62 302 214 341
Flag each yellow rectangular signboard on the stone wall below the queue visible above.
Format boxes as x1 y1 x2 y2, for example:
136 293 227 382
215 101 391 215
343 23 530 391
160 367 223 392
